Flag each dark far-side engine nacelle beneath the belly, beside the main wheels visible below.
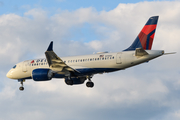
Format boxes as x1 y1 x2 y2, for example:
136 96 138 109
65 77 86 85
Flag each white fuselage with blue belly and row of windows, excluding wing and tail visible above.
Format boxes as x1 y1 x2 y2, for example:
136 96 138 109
7 50 164 79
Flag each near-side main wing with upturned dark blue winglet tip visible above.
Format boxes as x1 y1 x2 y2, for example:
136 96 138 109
45 41 79 73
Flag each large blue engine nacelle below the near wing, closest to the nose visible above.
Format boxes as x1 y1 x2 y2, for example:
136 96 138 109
32 68 53 81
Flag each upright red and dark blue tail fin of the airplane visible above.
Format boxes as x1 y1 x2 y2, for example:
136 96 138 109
124 16 159 51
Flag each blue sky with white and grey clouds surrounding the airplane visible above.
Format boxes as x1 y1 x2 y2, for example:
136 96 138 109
0 0 180 120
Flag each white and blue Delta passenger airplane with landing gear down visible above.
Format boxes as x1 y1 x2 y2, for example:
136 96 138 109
6 16 174 91
